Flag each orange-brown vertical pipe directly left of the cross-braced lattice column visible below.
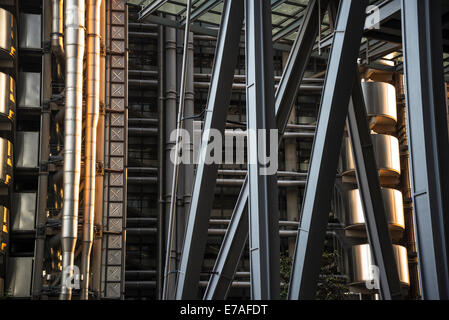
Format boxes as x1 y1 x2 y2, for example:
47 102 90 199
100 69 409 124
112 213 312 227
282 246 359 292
91 1 106 299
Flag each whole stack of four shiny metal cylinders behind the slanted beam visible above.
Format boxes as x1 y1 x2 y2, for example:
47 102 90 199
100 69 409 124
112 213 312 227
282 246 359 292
340 82 410 295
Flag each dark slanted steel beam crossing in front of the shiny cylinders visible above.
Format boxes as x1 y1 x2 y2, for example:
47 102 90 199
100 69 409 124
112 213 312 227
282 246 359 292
348 72 402 300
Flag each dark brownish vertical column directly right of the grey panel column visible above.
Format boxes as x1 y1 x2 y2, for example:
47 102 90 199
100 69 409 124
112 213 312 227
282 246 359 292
32 0 52 299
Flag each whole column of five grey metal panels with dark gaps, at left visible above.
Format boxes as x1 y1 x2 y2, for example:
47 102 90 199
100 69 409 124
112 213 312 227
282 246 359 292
5 1 44 298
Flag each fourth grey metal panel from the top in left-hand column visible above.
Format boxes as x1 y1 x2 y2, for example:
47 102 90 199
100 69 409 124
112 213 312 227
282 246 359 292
11 192 36 231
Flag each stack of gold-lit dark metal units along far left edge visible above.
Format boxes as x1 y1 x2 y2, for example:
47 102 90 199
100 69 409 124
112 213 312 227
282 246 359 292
0 1 17 295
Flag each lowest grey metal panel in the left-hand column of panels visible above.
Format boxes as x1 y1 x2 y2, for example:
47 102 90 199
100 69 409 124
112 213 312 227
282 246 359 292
5 257 33 298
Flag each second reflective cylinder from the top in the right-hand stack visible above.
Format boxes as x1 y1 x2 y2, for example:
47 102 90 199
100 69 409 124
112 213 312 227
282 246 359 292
341 134 401 184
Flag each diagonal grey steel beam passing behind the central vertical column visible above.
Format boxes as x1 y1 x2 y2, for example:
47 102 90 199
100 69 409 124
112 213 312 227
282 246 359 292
204 0 324 300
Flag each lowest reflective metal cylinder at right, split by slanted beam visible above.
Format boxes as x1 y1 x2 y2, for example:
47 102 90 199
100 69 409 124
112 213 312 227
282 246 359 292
350 244 410 292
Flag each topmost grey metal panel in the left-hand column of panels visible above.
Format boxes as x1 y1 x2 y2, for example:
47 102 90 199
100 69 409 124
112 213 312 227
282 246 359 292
19 13 42 49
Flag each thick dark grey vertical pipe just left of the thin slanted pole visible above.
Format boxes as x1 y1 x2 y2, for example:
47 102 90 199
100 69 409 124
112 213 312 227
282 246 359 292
164 18 176 300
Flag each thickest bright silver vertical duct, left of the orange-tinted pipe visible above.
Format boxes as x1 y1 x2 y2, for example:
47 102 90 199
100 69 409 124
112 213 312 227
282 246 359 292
60 0 85 300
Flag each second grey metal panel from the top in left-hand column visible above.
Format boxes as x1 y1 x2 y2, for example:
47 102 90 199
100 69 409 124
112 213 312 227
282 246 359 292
18 72 41 108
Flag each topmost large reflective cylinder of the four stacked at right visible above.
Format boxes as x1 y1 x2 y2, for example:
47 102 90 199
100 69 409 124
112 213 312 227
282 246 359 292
362 82 398 133
